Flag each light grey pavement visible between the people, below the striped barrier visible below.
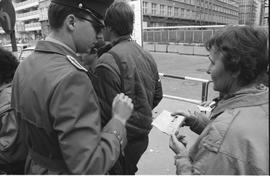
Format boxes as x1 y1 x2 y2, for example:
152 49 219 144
136 98 197 175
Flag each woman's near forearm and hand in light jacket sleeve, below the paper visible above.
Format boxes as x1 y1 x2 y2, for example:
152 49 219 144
169 120 239 175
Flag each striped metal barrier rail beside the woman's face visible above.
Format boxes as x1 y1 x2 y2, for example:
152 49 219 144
159 73 212 104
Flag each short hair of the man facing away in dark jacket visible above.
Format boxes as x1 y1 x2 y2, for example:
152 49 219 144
104 1 134 36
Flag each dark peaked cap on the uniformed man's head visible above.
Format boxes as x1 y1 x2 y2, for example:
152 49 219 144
52 0 114 19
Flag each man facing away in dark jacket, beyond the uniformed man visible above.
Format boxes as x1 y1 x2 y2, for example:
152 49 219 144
93 2 162 174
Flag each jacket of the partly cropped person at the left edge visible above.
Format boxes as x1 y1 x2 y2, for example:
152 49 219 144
0 84 27 170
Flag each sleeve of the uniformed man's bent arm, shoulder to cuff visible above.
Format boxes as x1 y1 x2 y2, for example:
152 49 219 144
49 72 126 174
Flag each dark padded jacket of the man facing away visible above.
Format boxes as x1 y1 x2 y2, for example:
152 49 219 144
94 36 162 140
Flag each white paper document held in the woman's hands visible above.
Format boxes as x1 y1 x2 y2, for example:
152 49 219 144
152 110 185 135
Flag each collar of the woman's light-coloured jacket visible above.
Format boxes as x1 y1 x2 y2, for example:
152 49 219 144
211 84 269 117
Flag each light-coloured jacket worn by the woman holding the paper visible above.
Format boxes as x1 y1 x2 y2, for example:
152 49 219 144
177 85 269 175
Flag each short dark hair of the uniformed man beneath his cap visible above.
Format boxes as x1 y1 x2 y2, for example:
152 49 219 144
48 3 87 30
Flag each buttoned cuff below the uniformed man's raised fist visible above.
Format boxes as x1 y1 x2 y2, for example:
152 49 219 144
103 118 127 154
